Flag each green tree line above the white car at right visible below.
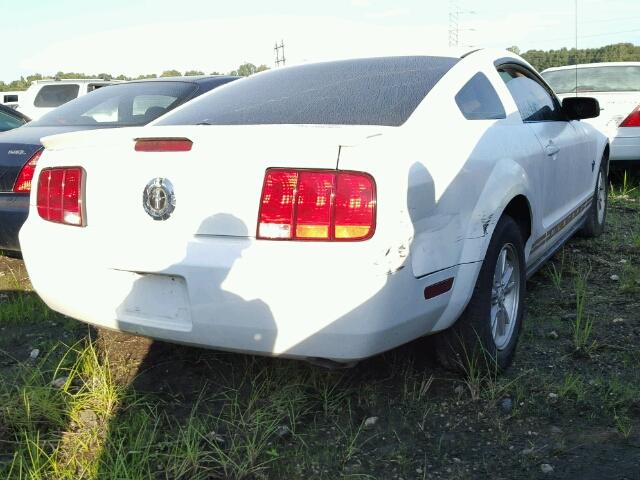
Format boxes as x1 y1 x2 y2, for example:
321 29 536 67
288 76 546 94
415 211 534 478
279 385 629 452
508 43 640 71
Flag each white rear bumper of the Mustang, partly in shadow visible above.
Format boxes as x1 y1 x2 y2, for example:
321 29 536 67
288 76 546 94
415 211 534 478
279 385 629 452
20 221 480 362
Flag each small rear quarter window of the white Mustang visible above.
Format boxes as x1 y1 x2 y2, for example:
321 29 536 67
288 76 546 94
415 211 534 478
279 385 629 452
456 72 506 120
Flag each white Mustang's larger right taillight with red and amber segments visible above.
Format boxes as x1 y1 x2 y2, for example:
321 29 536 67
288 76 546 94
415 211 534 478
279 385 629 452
257 168 376 241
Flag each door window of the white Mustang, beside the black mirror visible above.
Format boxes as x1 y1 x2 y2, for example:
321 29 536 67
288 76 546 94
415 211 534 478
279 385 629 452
498 69 565 122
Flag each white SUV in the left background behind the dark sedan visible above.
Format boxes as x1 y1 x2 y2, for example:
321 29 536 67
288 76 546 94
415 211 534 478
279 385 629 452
18 78 118 120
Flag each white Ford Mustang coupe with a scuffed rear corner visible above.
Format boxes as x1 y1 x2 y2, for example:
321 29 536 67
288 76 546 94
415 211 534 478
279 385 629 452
20 50 609 368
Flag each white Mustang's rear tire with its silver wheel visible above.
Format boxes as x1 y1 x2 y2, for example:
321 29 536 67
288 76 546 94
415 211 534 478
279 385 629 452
433 215 526 375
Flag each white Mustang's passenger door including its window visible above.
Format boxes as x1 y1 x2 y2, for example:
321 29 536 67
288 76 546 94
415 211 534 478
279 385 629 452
498 64 590 232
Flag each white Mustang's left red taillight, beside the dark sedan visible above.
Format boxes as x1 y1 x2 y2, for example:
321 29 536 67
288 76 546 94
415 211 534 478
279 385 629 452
36 167 84 226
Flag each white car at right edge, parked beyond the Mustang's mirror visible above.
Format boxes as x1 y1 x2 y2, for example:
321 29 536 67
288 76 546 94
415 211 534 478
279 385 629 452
542 62 640 165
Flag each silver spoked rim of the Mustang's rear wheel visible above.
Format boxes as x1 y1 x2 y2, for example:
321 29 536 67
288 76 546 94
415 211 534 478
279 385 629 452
491 243 520 350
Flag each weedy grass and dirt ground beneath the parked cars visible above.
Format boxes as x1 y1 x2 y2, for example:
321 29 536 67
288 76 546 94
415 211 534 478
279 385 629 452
0 173 640 480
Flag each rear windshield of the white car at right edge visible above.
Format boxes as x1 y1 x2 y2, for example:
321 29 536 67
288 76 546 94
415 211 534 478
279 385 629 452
542 65 640 93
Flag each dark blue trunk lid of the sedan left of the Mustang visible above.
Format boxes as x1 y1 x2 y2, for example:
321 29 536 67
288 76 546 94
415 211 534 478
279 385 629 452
0 125 104 192
